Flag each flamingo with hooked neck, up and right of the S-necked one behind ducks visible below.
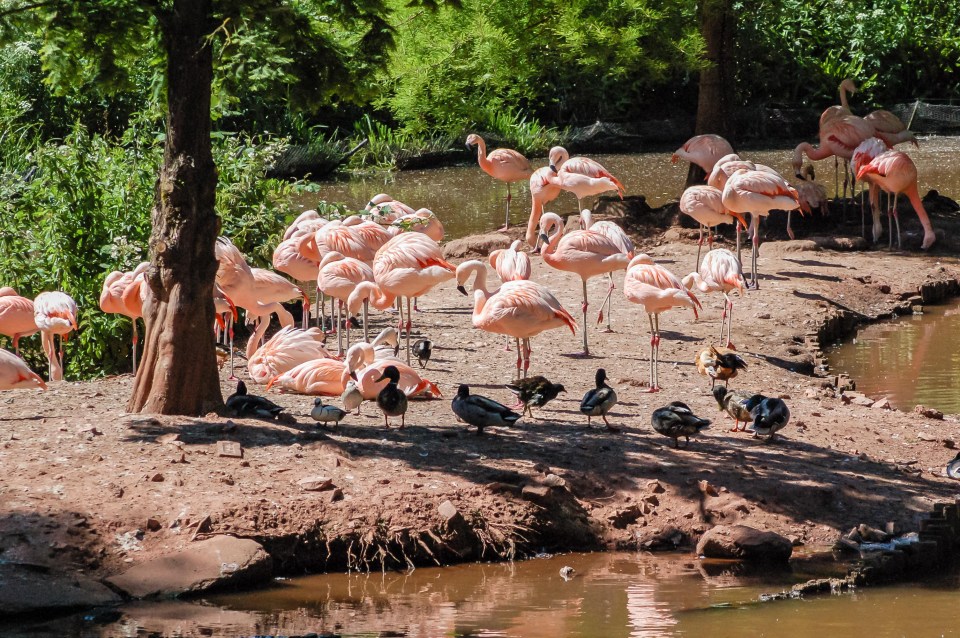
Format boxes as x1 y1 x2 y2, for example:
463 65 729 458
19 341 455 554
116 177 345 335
540 213 630 355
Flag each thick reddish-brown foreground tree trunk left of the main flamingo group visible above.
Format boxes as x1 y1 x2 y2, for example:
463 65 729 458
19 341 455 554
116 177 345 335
127 0 223 415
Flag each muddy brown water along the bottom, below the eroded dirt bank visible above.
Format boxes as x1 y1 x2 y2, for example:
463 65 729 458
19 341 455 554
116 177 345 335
13 553 960 638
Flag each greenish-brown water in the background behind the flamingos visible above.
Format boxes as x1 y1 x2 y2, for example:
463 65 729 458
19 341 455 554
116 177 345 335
298 137 960 239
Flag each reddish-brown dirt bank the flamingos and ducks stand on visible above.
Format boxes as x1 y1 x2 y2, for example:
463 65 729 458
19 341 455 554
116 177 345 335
0 208 960 588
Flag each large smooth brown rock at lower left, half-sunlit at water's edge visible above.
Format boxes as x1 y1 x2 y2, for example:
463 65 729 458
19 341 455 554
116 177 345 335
107 536 273 598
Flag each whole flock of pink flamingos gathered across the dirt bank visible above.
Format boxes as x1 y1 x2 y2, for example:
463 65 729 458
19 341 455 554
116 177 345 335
0 96 936 450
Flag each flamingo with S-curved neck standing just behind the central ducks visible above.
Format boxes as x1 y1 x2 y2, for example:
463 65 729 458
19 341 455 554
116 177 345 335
457 259 577 378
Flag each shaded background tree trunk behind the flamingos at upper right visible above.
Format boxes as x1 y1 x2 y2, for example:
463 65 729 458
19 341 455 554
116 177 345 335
696 0 736 139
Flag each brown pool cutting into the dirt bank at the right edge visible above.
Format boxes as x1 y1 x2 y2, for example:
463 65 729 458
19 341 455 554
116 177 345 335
826 302 960 414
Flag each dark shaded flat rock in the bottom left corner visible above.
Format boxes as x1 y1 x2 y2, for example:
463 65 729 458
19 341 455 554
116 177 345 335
0 561 120 618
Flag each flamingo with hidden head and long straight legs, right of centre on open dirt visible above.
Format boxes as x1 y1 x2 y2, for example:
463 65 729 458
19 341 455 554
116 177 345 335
623 253 701 392
